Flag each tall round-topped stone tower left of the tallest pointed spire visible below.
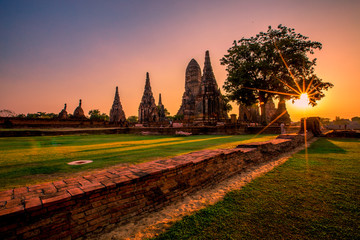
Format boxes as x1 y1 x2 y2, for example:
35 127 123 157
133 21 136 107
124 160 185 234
177 59 201 120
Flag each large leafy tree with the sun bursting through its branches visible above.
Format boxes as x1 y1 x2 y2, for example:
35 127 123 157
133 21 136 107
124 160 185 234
221 25 333 123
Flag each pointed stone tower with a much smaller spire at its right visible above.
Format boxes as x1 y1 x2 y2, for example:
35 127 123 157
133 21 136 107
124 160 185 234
139 72 159 123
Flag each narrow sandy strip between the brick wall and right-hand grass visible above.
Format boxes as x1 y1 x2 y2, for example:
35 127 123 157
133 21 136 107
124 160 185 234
96 138 316 240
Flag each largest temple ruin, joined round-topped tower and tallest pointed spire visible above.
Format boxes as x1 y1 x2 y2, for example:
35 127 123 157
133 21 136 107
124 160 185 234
178 51 228 122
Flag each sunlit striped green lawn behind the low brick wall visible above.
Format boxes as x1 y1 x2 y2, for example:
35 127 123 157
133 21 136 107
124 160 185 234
0 134 275 190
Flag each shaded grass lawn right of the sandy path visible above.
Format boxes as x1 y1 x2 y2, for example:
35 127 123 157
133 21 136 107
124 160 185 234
156 138 360 239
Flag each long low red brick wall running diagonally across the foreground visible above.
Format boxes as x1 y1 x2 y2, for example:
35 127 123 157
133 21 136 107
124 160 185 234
0 135 310 239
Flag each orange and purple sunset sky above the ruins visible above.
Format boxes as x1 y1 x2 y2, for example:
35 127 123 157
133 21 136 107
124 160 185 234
0 0 360 120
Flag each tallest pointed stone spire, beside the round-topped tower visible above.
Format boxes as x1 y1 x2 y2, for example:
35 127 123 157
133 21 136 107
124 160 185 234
195 51 228 122
